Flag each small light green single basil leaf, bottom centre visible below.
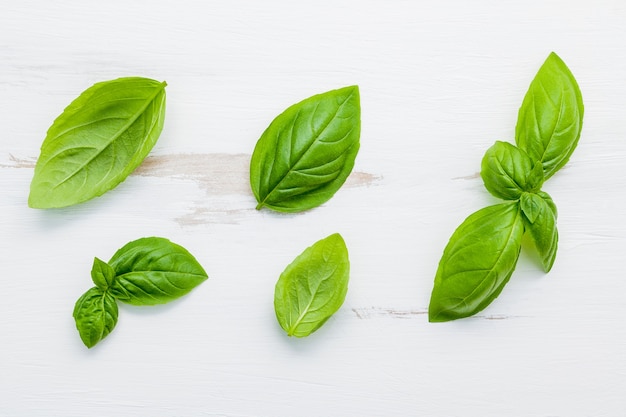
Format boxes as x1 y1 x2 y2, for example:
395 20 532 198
274 233 350 337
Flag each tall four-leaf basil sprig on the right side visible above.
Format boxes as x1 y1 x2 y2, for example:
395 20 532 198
428 53 584 322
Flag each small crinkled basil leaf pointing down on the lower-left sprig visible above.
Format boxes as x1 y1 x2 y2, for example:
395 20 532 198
73 287 118 348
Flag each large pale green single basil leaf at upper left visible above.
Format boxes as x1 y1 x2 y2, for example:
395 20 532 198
28 77 166 208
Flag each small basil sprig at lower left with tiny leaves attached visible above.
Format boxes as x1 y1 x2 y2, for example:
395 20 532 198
73 237 208 348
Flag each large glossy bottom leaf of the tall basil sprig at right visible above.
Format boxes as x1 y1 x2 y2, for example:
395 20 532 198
428 201 524 322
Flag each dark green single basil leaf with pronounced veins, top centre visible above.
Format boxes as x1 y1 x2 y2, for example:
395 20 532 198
250 86 361 212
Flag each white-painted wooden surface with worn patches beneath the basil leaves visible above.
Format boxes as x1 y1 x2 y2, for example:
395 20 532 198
0 0 626 417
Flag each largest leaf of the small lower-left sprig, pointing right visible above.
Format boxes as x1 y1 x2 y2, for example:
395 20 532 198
109 237 208 305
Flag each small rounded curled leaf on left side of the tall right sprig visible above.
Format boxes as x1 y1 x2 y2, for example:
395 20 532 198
480 141 543 200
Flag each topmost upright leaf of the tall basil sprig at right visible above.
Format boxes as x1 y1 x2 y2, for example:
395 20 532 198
515 52 584 179
